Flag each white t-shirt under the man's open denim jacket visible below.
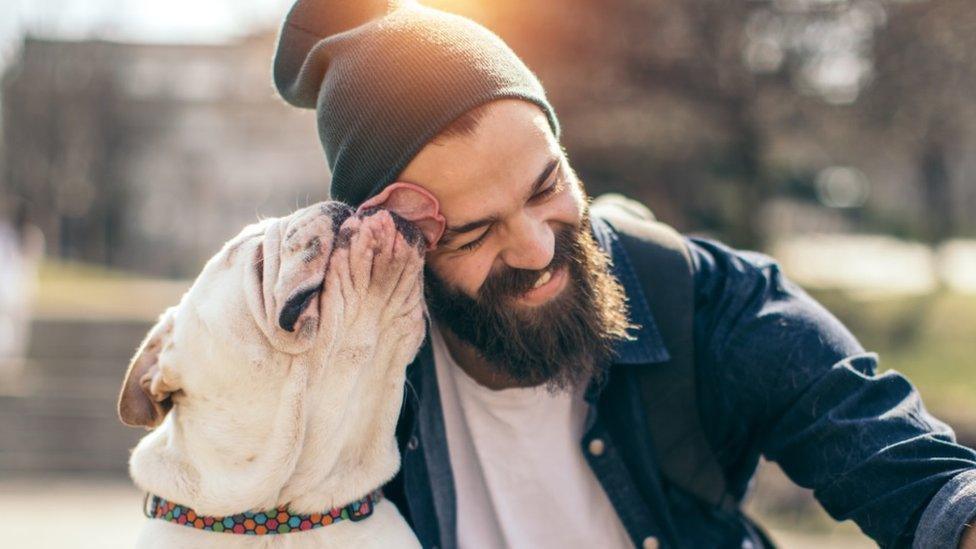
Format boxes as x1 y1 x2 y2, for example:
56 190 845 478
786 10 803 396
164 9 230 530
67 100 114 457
431 327 633 549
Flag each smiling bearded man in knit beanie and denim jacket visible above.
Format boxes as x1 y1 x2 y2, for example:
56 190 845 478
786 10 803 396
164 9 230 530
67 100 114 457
275 0 976 547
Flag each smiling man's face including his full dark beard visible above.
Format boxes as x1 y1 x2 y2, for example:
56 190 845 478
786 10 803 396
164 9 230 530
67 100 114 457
400 100 626 388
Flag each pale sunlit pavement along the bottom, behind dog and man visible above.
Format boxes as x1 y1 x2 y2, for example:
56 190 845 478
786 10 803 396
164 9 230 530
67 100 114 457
0 477 875 549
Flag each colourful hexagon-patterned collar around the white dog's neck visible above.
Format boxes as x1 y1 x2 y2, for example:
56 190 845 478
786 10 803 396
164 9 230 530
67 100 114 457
146 490 383 536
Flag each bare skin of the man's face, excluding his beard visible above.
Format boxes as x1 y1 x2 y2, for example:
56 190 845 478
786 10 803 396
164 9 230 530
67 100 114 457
400 100 585 296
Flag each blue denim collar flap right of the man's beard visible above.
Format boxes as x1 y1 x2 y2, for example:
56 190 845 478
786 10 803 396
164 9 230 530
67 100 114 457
590 216 671 364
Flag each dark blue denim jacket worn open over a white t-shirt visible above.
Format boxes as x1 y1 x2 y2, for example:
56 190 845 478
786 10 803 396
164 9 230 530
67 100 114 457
384 217 976 548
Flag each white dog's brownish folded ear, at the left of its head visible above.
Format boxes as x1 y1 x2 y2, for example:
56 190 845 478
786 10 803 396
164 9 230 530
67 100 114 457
119 307 178 429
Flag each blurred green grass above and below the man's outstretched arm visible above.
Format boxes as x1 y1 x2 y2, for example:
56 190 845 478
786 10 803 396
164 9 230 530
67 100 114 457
747 291 976 549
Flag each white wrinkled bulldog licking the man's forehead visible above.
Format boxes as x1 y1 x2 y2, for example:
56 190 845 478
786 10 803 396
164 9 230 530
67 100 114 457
119 202 425 549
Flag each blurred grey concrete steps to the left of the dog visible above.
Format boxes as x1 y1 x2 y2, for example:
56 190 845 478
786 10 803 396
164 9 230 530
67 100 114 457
0 319 152 473
